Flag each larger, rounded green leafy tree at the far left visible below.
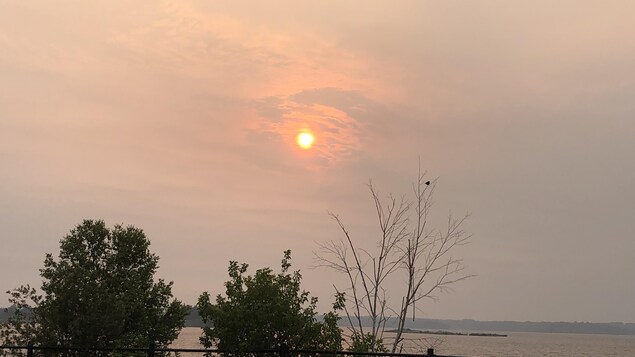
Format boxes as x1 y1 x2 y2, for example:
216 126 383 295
2 220 187 355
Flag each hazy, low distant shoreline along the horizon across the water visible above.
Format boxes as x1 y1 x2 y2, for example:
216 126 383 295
0 308 635 335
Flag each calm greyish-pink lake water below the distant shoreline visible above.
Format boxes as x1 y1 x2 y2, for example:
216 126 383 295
173 327 635 357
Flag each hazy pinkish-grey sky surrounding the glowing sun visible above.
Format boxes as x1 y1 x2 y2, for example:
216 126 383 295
0 0 635 322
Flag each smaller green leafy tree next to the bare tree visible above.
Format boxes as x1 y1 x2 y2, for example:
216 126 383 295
197 250 344 354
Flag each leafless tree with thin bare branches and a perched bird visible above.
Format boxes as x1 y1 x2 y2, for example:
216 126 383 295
315 170 471 353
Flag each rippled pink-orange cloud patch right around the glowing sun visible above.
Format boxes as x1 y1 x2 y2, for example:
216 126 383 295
248 88 390 168
